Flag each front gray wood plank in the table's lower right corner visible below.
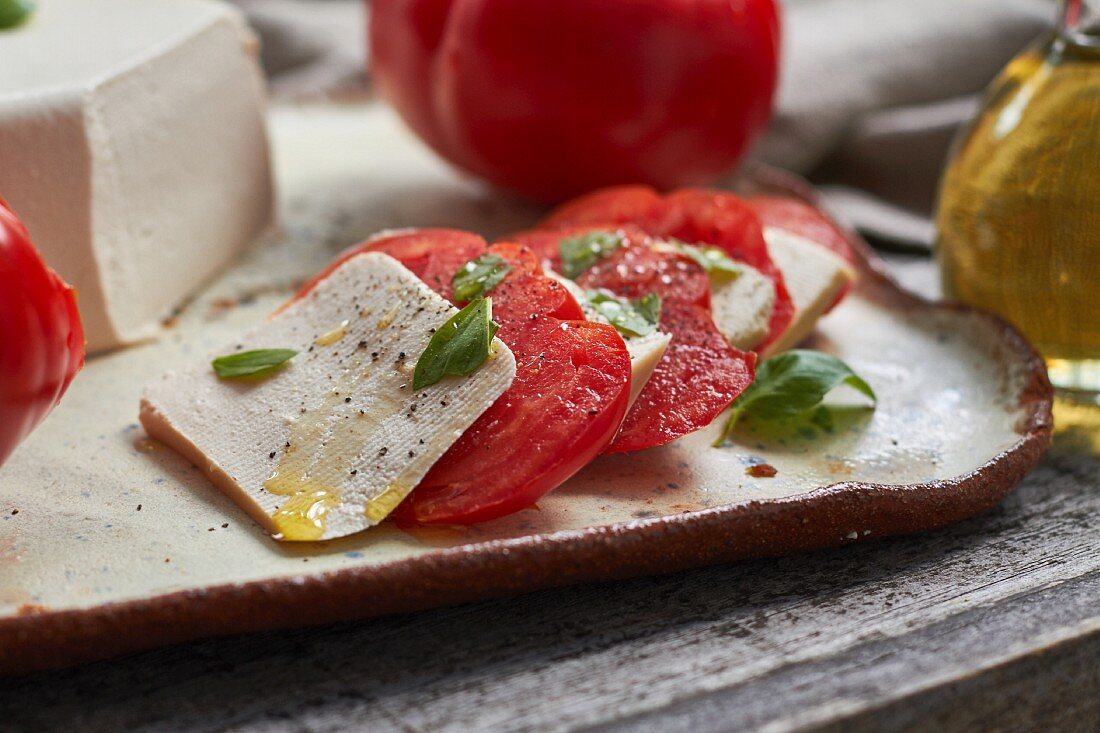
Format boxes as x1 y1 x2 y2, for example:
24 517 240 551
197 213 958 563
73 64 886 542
591 573 1100 733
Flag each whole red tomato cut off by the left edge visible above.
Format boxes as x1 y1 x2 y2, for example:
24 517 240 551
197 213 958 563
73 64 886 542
0 198 84 463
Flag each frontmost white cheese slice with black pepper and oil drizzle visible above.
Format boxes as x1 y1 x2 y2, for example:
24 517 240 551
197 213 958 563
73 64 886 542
141 253 516 539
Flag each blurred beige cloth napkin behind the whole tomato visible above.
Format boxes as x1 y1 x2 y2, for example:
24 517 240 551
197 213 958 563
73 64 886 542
238 0 1056 247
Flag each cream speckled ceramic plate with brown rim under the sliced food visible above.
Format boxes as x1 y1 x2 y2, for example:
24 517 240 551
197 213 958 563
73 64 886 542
0 106 1051 674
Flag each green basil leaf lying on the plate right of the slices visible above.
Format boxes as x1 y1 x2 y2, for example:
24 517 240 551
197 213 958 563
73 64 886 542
714 349 878 446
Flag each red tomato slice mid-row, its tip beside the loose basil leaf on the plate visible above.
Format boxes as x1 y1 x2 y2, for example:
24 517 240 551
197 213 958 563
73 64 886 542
605 299 756 453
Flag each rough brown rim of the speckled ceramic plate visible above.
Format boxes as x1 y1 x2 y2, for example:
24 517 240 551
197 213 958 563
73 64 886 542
0 166 1053 675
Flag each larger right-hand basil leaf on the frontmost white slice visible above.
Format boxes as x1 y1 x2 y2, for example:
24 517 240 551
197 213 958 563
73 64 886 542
413 298 501 391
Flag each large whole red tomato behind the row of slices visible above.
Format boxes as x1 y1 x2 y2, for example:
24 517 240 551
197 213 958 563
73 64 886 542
371 0 779 201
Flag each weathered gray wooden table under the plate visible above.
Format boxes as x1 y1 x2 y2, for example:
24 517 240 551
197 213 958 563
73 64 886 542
0 248 1100 733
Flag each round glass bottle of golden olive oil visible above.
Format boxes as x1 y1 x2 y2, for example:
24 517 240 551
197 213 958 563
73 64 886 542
936 32 1100 392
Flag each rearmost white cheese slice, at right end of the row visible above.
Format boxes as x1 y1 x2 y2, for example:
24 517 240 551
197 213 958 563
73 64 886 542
762 227 856 358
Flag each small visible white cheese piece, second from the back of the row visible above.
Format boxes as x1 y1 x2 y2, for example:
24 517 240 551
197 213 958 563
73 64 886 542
711 263 776 351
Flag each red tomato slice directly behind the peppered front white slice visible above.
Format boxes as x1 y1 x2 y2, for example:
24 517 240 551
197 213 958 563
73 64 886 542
394 316 630 524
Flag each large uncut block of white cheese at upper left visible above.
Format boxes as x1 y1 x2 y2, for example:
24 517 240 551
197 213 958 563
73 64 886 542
0 0 273 350
